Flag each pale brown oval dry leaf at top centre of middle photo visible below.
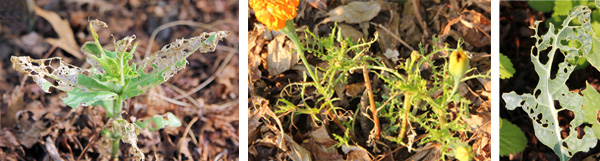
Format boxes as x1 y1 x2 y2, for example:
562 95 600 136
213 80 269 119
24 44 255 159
323 1 381 24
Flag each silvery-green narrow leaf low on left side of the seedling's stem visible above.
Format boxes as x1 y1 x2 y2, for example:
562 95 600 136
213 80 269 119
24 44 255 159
62 90 117 108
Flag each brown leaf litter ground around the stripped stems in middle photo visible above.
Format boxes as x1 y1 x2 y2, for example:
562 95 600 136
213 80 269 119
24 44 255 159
248 0 491 160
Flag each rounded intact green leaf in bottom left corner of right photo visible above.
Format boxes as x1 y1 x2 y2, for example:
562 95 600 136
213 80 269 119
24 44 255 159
500 119 527 156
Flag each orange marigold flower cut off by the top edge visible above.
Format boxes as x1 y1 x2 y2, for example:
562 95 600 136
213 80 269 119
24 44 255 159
248 0 300 30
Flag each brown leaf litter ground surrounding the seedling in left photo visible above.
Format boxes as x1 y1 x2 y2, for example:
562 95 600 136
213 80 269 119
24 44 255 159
0 0 239 160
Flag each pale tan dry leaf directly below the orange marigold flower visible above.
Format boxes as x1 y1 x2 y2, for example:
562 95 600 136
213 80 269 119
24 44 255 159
267 35 300 76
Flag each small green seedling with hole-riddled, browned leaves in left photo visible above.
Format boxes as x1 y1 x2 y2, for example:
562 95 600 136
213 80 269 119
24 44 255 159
11 20 229 160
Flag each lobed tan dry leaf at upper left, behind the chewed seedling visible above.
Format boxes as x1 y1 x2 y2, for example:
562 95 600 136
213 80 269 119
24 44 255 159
34 5 84 60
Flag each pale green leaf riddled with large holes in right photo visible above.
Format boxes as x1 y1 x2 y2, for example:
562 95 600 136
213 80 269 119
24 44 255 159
502 6 597 161
